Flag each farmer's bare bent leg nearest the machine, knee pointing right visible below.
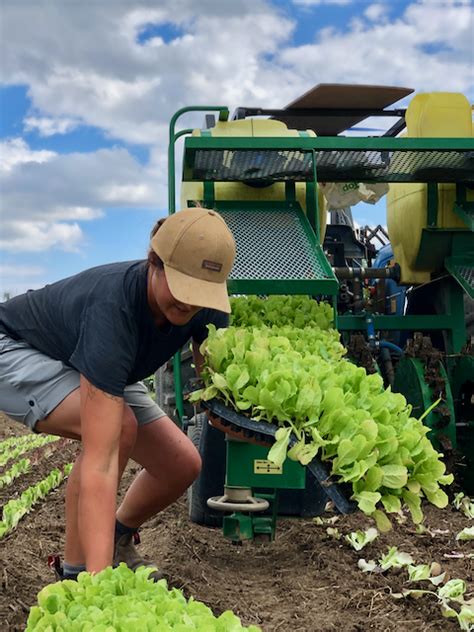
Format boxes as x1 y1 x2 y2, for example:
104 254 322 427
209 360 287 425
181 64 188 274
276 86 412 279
117 417 201 528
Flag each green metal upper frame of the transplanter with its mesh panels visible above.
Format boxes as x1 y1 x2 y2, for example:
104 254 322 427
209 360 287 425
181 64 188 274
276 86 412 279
168 106 474 420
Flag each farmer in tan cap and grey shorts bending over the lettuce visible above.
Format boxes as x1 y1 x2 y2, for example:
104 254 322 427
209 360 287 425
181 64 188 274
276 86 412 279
0 208 235 579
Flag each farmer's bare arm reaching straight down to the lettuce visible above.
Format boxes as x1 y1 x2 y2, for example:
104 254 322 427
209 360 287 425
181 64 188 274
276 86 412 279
79 375 124 572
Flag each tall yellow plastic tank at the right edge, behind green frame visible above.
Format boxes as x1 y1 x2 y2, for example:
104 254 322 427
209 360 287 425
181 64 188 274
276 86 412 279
387 92 474 284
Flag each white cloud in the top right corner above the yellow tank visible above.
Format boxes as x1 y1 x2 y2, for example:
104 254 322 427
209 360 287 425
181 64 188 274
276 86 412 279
278 0 474 98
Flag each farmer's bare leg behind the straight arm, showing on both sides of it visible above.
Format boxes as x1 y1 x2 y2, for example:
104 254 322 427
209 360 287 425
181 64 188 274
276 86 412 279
35 389 137 566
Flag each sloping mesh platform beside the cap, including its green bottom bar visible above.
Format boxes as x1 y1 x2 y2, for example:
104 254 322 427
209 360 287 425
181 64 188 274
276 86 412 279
218 202 337 294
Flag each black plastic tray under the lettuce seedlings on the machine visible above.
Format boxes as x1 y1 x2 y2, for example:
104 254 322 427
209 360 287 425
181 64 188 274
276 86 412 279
201 399 357 514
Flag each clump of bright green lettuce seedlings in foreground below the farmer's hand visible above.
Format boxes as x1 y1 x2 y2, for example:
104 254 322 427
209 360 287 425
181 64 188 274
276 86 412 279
25 563 260 632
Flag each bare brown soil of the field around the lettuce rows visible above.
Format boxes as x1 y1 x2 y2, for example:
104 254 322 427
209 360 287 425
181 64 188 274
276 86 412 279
0 417 474 632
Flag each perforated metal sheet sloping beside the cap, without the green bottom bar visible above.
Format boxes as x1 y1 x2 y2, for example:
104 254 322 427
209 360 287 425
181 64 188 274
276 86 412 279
219 208 334 281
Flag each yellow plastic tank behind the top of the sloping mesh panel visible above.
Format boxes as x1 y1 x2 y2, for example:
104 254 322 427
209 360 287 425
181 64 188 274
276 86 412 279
181 119 327 243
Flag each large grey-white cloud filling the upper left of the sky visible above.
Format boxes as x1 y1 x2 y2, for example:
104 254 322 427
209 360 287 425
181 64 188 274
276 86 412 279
0 0 298 144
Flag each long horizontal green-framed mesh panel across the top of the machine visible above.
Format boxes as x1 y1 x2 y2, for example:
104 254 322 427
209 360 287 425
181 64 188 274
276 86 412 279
184 137 474 184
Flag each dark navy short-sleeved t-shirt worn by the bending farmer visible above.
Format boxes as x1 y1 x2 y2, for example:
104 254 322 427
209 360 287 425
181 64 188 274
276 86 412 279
0 261 228 396
